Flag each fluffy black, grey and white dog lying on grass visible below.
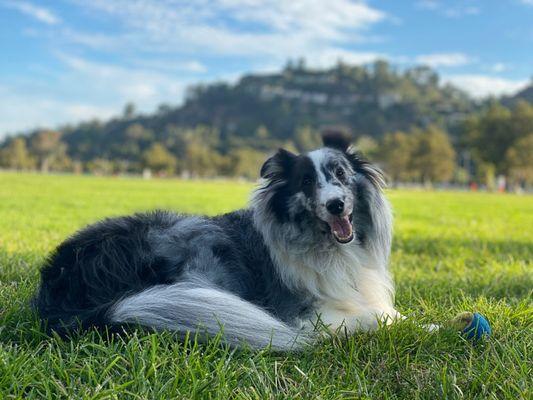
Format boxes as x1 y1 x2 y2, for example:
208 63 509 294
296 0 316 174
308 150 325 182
33 132 402 351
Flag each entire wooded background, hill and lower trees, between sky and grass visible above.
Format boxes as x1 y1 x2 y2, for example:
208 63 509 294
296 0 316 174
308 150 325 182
0 62 533 187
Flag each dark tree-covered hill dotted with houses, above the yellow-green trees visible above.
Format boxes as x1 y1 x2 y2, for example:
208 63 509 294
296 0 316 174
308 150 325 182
52 62 474 161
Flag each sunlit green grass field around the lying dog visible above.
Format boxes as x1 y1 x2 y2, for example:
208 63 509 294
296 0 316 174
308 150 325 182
0 173 533 399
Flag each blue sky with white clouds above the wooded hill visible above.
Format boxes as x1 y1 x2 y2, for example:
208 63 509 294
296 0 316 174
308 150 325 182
0 0 533 137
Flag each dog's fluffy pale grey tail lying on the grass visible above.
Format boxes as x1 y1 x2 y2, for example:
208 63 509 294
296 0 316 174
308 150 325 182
108 281 310 351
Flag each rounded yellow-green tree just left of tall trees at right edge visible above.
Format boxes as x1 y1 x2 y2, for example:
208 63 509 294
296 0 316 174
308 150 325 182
411 126 455 183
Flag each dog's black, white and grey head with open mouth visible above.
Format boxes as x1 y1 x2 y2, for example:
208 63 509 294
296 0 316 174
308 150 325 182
260 131 383 244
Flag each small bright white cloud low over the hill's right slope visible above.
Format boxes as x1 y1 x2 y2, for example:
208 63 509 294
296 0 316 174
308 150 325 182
443 74 529 98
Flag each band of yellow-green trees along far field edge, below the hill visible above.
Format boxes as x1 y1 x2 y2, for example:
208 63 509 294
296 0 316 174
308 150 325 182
0 101 533 186
